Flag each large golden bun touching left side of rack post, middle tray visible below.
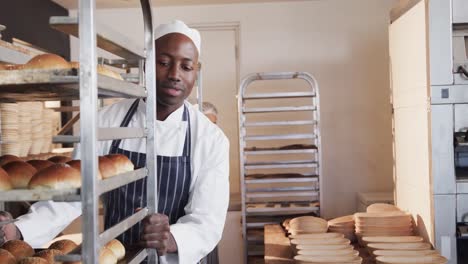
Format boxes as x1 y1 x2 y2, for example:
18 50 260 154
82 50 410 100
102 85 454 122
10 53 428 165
29 163 81 190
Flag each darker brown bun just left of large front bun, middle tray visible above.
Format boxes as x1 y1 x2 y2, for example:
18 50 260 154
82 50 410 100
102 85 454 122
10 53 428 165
3 161 37 189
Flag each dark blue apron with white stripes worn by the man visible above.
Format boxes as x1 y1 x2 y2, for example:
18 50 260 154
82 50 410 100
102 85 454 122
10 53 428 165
104 100 192 250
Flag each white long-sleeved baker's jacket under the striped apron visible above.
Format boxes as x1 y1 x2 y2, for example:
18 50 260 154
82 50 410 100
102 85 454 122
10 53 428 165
16 100 229 264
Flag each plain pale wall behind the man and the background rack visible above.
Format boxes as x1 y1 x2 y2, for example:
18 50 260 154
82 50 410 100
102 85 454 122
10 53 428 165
72 0 396 217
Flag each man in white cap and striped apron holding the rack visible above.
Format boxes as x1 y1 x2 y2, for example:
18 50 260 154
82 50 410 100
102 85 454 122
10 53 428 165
0 21 229 264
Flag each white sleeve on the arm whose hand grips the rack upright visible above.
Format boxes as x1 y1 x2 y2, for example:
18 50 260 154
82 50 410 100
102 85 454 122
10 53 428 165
170 136 229 264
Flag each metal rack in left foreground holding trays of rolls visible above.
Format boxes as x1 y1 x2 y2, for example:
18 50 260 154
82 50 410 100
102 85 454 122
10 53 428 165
0 0 158 264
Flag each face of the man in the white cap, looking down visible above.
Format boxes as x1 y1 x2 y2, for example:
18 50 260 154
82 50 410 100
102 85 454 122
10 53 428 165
156 33 198 108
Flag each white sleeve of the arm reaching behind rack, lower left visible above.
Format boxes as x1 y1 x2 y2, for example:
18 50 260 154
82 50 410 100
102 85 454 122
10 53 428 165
15 201 81 248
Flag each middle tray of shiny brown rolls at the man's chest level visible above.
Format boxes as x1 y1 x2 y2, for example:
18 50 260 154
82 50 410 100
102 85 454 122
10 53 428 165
0 154 139 201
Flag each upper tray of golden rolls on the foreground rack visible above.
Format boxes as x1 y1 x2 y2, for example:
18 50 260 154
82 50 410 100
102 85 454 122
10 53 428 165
0 53 145 101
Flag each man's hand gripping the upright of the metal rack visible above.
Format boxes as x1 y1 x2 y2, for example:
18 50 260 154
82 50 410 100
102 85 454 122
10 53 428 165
140 214 177 256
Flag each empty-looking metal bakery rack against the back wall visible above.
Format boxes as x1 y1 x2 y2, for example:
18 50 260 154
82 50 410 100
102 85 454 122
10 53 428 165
238 72 321 263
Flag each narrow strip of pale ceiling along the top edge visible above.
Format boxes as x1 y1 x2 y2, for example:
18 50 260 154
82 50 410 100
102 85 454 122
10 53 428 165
52 0 300 9
